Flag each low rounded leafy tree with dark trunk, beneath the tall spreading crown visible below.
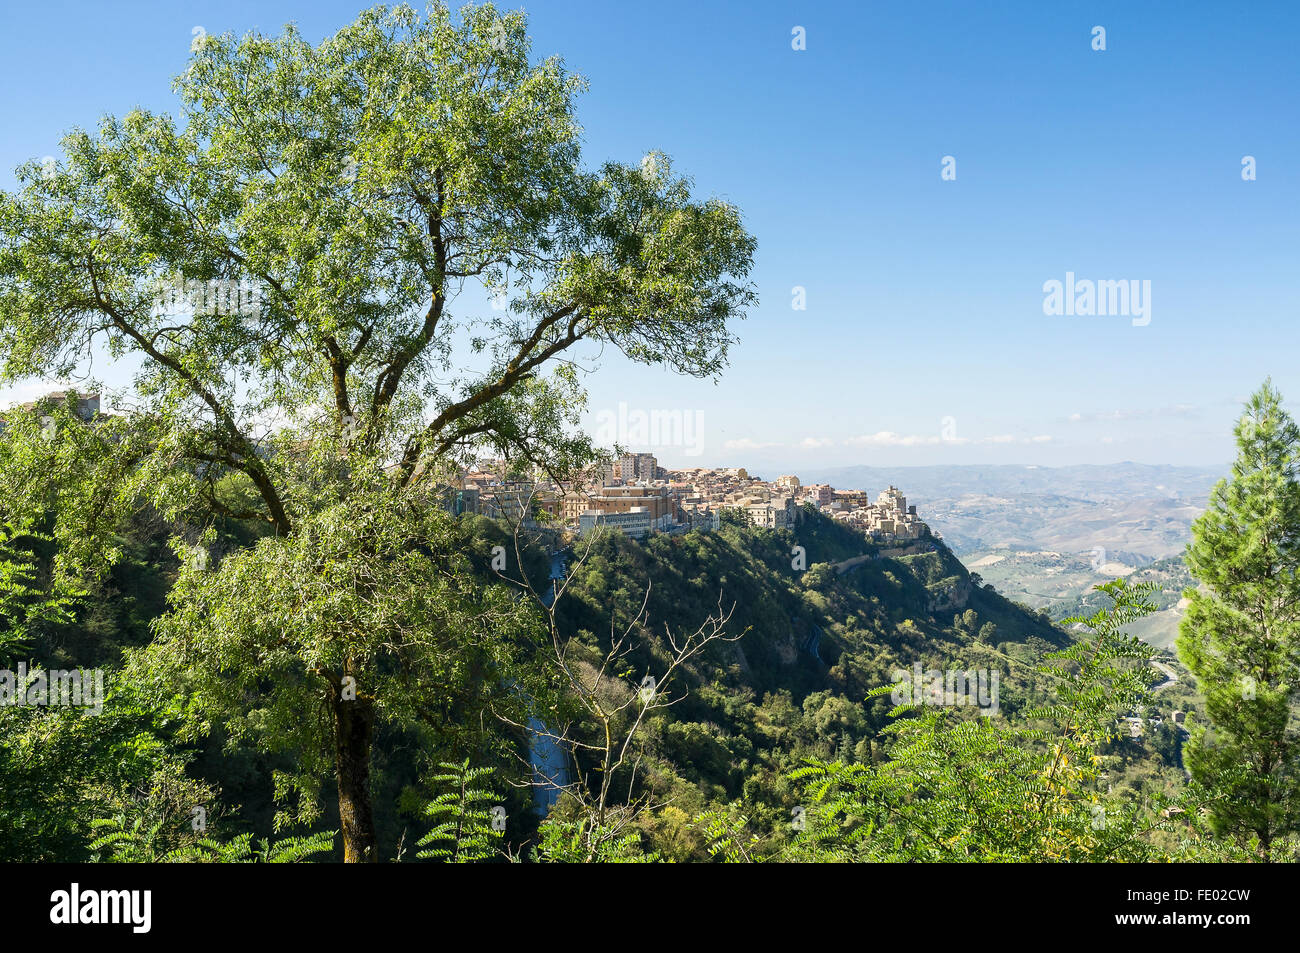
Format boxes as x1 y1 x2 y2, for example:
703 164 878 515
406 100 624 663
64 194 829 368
127 488 546 862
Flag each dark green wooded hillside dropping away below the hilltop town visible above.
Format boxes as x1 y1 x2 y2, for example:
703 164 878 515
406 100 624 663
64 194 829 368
533 512 1133 859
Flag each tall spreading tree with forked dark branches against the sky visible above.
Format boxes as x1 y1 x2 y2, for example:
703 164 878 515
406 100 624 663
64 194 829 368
0 3 755 859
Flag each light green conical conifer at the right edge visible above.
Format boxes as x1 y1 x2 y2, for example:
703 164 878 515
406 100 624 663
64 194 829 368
1178 381 1300 862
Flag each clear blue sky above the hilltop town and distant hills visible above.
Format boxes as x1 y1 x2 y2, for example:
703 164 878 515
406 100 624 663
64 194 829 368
0 0 1300 475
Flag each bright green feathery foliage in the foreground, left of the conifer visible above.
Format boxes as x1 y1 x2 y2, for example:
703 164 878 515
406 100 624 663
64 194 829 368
787 580 1167 862
